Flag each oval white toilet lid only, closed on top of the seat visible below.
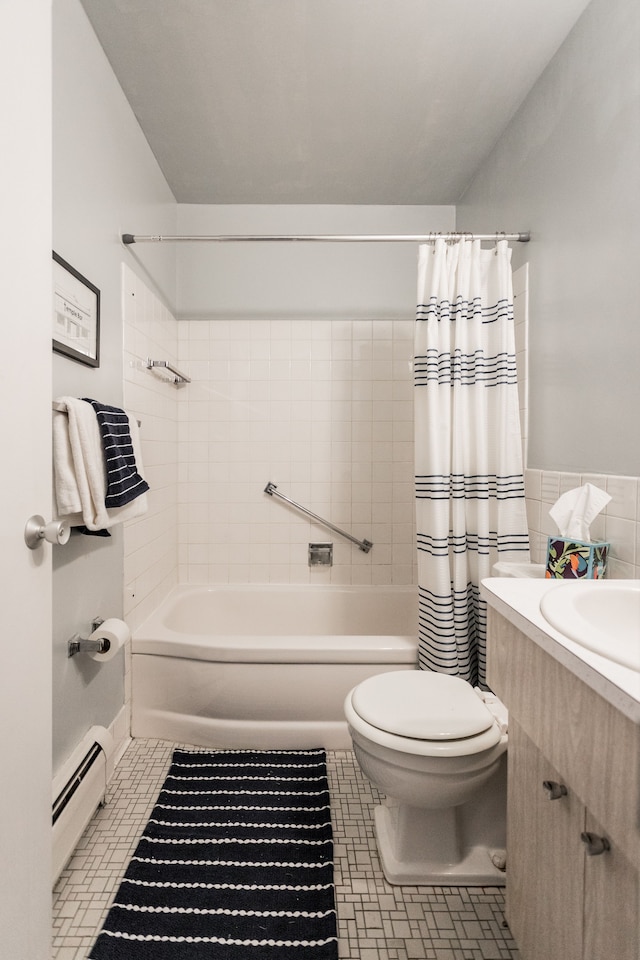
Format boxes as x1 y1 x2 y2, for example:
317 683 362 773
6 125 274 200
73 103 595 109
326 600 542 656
351 670 494 740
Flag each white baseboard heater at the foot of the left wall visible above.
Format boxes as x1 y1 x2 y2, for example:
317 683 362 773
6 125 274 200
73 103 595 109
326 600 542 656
51 727 114 885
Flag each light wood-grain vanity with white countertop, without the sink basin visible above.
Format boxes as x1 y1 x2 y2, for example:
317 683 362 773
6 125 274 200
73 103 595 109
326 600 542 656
483 579 640 960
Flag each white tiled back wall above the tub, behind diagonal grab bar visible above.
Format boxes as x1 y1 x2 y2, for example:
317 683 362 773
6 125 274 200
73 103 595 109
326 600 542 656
178 319 415 584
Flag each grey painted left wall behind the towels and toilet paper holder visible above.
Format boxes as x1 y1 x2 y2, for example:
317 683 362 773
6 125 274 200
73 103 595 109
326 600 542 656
53 0 176 769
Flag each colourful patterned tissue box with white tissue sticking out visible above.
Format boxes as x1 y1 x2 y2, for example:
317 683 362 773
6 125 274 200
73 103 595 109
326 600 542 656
545 483 611 580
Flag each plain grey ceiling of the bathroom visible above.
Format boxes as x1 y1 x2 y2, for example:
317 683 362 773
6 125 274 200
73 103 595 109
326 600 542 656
81 0 588 204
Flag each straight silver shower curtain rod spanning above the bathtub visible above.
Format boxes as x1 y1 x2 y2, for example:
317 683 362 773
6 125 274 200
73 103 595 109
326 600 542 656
122 231 530 244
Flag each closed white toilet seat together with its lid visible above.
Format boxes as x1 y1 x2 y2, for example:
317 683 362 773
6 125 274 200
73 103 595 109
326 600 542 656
346 670 502 756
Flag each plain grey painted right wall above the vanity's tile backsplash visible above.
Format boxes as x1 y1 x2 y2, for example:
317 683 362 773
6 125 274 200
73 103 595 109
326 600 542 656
458 0 640 477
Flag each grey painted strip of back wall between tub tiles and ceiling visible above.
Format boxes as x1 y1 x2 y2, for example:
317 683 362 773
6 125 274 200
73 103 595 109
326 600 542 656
177 204 455 320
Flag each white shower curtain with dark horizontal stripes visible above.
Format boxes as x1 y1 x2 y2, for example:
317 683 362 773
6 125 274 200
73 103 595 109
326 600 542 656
414 238 529 686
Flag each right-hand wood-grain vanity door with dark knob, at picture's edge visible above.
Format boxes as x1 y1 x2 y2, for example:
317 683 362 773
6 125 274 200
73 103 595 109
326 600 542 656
584 811 640 960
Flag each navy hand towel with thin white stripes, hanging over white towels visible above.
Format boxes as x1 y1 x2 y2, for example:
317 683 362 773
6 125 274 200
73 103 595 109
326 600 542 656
82 397 149 509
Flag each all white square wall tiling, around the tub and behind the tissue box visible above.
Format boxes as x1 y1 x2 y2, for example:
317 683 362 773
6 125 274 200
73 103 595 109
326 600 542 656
123 258 640 629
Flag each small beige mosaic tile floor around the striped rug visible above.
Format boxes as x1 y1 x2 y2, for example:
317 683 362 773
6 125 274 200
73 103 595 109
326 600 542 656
52 740 518 960
